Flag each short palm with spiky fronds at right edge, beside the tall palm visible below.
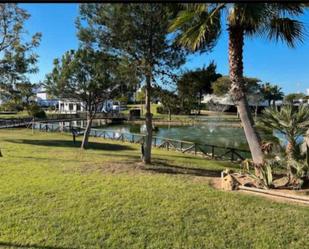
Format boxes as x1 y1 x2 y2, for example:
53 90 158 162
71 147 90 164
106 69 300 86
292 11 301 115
260 105 309 185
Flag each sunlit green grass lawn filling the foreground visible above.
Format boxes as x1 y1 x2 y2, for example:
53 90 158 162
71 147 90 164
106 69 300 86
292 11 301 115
0 129 309 249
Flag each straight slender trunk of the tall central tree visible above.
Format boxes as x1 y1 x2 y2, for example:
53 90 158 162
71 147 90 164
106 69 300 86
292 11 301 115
143 70 152 164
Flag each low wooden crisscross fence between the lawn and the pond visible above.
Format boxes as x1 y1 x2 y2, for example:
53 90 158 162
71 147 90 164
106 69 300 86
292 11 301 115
34 122 251 161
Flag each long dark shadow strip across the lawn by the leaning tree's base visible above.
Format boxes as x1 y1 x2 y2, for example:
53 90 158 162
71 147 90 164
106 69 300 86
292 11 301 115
5 139 134 151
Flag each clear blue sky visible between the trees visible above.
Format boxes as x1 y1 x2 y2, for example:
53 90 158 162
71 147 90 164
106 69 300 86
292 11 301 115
20 3 309 94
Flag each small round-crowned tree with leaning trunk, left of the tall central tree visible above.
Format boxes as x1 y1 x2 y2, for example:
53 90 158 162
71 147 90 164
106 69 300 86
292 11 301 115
45 48 119 149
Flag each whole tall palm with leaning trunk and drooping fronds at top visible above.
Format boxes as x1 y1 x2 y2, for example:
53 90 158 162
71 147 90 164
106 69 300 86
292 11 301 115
170 3 303 169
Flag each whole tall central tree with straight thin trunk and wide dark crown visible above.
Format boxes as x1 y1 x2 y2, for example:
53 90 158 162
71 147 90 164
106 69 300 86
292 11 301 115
78 4 184 164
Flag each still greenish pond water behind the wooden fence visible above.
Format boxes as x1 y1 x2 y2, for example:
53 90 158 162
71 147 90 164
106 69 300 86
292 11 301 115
54 117 292 150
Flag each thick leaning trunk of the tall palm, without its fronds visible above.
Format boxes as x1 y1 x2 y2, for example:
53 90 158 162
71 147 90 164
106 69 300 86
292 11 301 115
229 27 264 169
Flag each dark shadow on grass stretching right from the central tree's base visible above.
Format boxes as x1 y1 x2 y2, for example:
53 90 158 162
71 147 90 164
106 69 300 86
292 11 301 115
145 160 221 177
